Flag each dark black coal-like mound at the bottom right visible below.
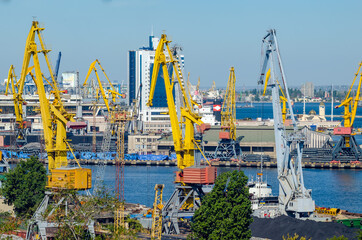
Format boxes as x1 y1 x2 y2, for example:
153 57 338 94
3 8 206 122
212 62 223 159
250 216 358 240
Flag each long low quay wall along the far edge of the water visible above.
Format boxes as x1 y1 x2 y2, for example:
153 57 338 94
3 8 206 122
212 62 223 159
8 158 362 169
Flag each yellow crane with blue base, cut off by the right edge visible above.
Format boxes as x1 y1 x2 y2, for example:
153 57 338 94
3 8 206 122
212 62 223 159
332 62 362 162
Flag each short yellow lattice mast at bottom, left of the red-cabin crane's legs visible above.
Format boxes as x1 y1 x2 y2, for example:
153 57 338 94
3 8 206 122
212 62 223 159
151 184 164 240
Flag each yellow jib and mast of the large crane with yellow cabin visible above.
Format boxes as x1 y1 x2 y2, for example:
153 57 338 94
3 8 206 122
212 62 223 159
13 21 89 178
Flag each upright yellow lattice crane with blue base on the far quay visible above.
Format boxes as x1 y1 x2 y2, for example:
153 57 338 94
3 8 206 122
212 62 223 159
214 67 243 161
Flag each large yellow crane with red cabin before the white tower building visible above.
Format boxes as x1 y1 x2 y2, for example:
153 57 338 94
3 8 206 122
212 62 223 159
147 34 216 234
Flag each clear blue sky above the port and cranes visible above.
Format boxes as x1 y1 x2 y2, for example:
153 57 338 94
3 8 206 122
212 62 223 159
0 0 362 88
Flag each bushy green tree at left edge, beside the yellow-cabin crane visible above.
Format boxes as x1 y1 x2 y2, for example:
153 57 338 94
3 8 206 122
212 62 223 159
1 157 46 217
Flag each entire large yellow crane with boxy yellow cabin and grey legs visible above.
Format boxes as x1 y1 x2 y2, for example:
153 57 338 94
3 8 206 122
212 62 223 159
12 21 94 240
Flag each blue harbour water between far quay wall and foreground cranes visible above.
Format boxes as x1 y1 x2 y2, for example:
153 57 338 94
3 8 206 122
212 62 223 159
91 166 362 213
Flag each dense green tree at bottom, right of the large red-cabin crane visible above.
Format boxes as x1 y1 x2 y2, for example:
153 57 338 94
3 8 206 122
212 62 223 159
191 171 253 239
